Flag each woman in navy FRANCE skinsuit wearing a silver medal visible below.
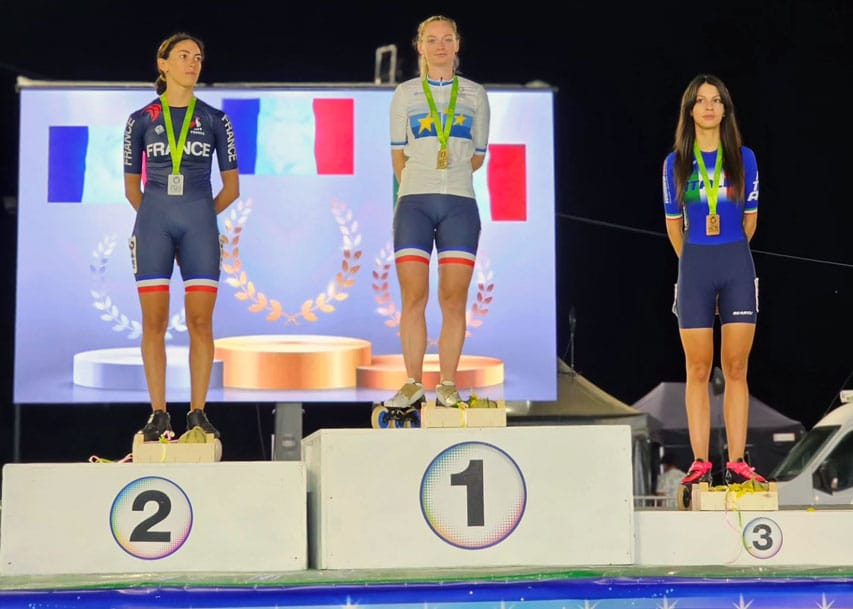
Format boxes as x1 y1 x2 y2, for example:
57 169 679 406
124 33 239 441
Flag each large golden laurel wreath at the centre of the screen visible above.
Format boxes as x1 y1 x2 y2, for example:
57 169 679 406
222 199 362 325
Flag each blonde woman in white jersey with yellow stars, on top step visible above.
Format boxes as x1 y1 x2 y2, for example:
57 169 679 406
385 15 489 408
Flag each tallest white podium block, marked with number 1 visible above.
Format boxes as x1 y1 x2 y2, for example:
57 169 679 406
302 425 634 569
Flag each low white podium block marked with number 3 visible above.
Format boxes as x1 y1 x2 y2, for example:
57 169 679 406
635 509 853 567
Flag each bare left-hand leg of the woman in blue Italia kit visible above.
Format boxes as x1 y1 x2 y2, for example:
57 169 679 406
680 328 714 461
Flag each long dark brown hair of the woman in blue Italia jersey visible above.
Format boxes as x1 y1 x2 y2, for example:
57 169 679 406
673 74 745 205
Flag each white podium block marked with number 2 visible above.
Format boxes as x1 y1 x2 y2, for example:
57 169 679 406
0 461 308 575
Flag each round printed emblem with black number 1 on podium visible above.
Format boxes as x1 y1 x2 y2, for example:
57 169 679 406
421 442 527 550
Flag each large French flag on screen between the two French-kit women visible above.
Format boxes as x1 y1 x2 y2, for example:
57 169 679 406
222 96 355 176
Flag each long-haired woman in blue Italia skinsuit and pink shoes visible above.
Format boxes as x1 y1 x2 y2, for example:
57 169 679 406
663 74 766 485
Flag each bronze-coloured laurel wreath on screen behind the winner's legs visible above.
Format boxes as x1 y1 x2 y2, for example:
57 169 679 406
373 243 495 347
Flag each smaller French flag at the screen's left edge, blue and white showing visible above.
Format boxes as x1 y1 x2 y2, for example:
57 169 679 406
47 125 126 203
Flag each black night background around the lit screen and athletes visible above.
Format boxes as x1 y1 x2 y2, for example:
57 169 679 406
0 0 853 462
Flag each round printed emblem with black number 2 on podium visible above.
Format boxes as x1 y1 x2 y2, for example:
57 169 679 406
110 476 193 560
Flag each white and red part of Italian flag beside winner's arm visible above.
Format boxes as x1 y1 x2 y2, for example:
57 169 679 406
474 144 527 222
